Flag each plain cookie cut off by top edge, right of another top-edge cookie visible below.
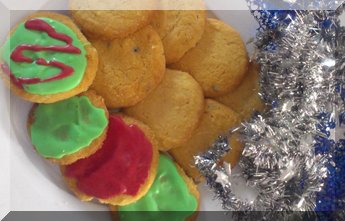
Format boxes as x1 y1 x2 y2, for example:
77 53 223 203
151 10 206 64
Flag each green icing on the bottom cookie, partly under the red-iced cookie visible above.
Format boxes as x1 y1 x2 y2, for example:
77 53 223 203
118 154 198 221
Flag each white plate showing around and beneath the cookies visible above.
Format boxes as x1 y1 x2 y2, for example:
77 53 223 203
0 0 257 220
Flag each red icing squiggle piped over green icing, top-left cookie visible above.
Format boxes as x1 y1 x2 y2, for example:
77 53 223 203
1 19 81 88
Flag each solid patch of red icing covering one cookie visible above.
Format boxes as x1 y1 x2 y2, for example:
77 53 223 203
65 116 153 199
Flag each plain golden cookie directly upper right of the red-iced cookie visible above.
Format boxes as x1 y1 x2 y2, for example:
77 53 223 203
124 70 204 151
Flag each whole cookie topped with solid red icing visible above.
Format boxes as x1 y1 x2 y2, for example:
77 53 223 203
61 115 159 205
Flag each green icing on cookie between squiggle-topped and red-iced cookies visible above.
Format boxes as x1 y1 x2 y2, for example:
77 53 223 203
30 96 108 159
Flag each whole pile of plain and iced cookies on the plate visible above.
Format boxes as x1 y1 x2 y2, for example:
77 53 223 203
0 0 264 220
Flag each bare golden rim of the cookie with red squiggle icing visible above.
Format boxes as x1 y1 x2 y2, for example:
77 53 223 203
0 12 98 103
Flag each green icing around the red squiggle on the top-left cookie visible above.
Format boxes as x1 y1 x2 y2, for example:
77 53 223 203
2 18 87 95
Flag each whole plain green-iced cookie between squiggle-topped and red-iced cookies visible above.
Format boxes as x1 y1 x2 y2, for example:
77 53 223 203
28 91 108 165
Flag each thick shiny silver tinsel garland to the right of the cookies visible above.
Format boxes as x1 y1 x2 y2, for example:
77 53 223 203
195 3 345 214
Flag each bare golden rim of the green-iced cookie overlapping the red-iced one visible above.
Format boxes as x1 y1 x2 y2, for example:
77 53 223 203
27 90 109 165
